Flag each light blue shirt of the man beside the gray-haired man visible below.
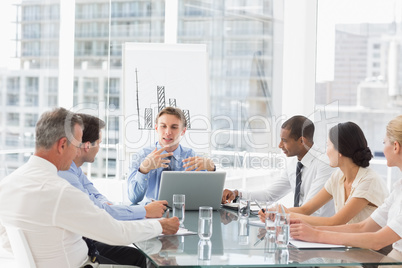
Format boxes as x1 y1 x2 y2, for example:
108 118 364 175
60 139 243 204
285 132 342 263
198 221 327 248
58 161 146 221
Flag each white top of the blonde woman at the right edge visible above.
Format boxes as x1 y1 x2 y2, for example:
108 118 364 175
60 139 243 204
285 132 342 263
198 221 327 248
370 179 402 252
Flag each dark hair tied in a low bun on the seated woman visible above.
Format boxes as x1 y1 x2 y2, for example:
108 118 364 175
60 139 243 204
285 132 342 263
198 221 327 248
329 122 373 167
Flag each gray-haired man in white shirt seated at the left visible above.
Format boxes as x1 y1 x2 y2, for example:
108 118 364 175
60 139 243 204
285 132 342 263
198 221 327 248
0 108 179 267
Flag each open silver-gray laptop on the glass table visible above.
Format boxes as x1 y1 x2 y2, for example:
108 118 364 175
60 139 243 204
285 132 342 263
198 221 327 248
158 171 226 210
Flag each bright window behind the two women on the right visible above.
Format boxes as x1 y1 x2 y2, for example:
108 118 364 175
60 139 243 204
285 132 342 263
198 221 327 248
316 0 402 186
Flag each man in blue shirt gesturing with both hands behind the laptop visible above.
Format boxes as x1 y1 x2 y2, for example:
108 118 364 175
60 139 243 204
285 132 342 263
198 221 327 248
127 107 216 204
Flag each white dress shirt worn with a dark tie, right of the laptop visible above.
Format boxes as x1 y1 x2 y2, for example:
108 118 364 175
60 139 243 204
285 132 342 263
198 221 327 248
240 145 335 217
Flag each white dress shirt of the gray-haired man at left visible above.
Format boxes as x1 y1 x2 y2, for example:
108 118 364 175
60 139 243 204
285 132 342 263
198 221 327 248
0 156 162 268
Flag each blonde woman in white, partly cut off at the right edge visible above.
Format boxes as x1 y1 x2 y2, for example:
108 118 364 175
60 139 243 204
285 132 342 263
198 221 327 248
290 116 402 261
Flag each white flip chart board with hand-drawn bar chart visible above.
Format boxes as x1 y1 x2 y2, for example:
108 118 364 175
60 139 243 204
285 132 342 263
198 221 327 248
121 42 211 154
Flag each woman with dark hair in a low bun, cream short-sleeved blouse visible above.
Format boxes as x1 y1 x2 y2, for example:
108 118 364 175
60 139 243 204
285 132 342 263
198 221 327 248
260 122 388 226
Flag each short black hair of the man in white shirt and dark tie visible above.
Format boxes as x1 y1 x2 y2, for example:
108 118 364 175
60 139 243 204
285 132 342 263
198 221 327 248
282 115 315 142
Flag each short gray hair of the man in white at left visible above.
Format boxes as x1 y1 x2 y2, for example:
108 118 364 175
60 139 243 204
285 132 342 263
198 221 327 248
35 108 84 149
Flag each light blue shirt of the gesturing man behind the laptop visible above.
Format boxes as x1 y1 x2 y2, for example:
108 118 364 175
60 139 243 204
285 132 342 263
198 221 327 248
127 143 196 204
